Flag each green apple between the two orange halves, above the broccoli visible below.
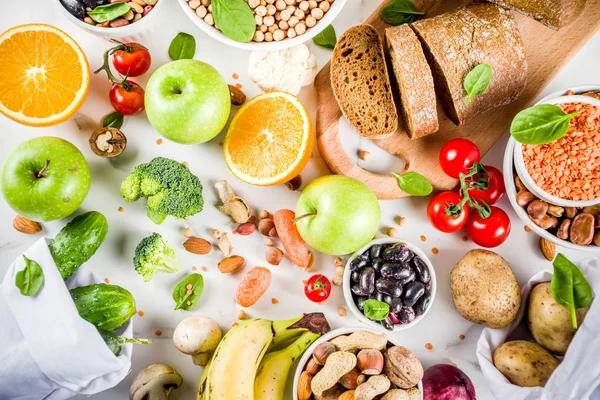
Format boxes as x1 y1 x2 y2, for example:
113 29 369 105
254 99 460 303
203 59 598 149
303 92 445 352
145 60 231 144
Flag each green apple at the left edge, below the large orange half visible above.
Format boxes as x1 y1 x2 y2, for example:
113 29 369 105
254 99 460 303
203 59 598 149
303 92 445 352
1 136 91 222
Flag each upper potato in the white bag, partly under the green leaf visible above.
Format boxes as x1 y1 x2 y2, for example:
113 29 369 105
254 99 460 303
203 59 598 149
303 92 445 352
527 282 589 356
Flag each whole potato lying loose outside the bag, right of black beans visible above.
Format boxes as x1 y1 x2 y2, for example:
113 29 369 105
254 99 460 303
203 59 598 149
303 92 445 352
450 250 521 329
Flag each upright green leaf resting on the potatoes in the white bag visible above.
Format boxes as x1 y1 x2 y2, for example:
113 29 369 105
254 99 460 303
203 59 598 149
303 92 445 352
550 253 593 328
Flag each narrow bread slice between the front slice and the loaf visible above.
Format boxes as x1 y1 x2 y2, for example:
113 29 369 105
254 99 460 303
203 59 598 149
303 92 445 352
385 25 440 139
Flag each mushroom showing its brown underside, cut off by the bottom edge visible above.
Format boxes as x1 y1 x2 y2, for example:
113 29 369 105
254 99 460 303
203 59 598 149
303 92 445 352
129 364 183 400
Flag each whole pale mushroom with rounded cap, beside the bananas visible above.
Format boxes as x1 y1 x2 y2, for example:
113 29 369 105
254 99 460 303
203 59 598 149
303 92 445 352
173 316 222 366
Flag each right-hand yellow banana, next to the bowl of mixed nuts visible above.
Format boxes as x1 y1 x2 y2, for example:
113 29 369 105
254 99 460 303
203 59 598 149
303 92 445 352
253 331 321 400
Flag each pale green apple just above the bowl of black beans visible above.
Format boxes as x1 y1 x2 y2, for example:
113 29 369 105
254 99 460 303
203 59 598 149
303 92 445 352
296 175 381 255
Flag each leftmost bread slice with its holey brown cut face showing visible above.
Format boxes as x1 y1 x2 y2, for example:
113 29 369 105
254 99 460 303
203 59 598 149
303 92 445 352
331 24 398 139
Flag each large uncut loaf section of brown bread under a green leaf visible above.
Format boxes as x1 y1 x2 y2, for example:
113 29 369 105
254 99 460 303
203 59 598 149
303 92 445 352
411 1 527 125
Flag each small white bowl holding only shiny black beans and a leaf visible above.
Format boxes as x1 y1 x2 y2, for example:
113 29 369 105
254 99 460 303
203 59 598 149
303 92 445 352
342 238 437 333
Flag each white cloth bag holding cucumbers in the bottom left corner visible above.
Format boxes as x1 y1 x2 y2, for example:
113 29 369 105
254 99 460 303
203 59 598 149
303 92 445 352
0 238 133 400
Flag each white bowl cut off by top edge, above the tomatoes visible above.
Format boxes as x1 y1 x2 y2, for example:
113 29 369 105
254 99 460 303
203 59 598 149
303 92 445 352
54 0 170 40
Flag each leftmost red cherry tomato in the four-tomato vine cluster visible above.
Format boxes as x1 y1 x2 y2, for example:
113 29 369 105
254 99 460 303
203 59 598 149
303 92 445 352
427 192 470 233
